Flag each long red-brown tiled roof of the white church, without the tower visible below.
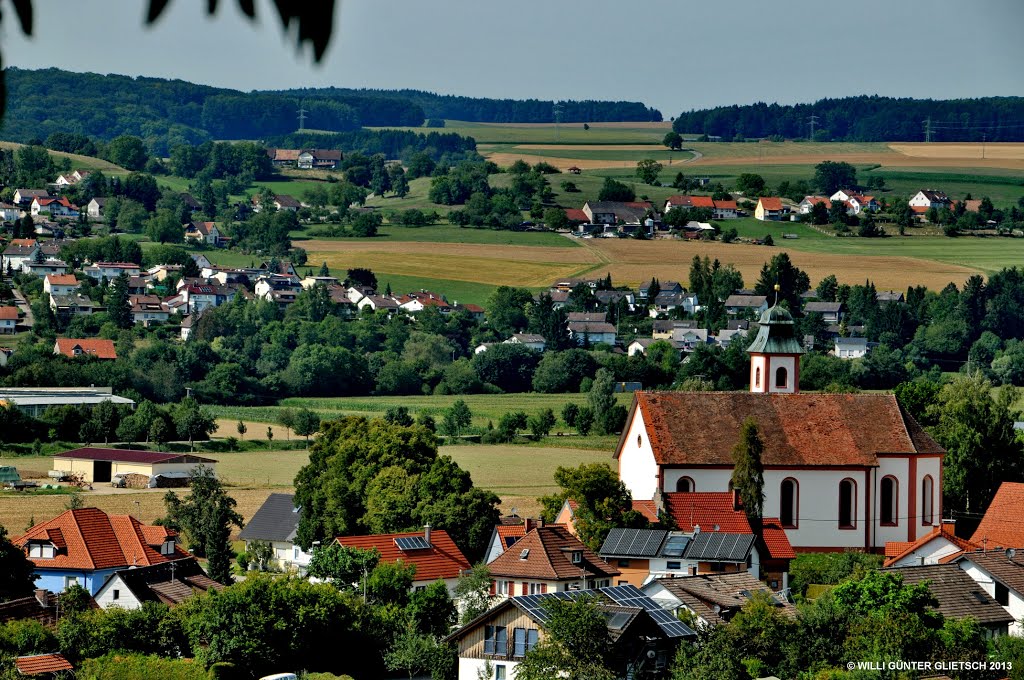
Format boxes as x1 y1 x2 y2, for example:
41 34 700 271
615 392 944 467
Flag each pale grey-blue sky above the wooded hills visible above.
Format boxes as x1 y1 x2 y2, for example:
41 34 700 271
0 0 1024 118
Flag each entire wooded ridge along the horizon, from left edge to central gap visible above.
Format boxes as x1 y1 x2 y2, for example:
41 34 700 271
0 68 662 155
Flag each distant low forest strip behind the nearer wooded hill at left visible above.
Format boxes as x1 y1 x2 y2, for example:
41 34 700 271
275 87 662 125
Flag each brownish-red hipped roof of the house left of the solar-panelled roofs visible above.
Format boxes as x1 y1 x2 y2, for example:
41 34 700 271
487 524 620 581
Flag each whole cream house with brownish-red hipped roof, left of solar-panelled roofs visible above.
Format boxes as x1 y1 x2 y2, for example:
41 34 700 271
487 524 621 597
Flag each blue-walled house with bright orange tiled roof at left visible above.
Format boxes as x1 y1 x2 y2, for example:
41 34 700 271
11 508 193 595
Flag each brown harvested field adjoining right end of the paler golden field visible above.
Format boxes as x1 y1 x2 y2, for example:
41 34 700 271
588 239 978 290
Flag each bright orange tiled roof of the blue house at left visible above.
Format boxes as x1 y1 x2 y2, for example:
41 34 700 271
11 508 190 570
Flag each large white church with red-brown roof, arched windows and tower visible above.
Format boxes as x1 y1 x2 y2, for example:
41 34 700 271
614 305 945 552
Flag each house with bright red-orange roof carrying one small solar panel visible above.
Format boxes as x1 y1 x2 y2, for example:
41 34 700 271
335 524 471 593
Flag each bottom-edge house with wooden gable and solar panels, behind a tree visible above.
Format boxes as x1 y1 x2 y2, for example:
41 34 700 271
444 586 696 680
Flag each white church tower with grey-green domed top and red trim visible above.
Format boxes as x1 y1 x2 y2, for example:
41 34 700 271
746 301 804 394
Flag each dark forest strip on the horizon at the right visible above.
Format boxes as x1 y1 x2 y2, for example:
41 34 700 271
673 95 1024 141
